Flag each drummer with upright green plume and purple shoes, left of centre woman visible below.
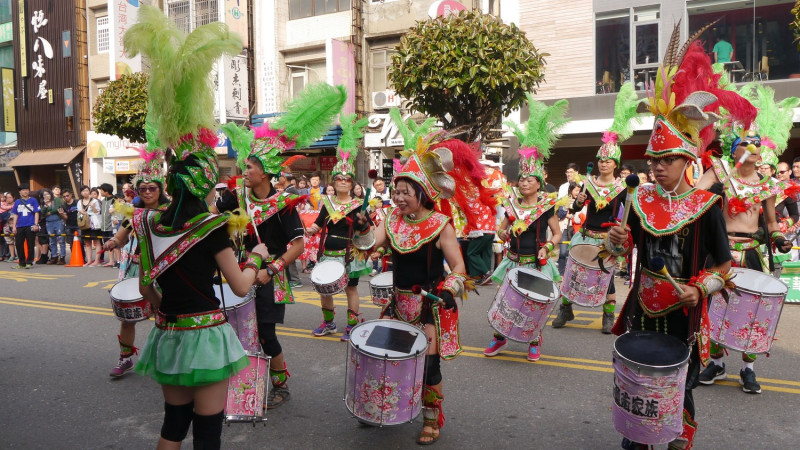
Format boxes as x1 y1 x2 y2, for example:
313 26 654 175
306 114 372 341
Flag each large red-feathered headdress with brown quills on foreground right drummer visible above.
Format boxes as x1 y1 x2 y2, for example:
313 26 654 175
645 21 756 160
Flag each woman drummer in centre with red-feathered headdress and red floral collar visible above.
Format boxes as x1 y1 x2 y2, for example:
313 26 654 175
372 135 482 445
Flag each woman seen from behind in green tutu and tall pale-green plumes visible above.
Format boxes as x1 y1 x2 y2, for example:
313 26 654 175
124 5 252 449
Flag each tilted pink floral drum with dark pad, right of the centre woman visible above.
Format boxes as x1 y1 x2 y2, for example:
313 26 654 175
488 267 559 343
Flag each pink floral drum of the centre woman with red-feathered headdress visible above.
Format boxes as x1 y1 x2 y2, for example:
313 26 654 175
344 319 428 426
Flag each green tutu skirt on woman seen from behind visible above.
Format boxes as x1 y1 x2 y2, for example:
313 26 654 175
136 323 250 386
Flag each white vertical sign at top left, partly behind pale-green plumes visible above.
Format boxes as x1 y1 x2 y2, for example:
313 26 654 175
108 0 142 81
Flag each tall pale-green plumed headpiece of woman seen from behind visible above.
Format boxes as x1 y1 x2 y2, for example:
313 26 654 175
124 5 242 198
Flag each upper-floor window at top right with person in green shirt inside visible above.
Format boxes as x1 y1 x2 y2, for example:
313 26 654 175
686 0 800 82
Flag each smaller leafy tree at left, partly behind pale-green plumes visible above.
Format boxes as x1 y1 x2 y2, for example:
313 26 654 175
92 72 149 143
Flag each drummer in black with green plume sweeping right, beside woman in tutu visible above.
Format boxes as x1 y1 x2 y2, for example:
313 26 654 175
217 84 346 409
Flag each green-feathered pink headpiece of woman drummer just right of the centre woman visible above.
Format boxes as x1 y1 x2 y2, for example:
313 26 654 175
504 94 570 185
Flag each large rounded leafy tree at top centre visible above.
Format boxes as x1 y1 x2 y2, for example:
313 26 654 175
389 11 549 142
